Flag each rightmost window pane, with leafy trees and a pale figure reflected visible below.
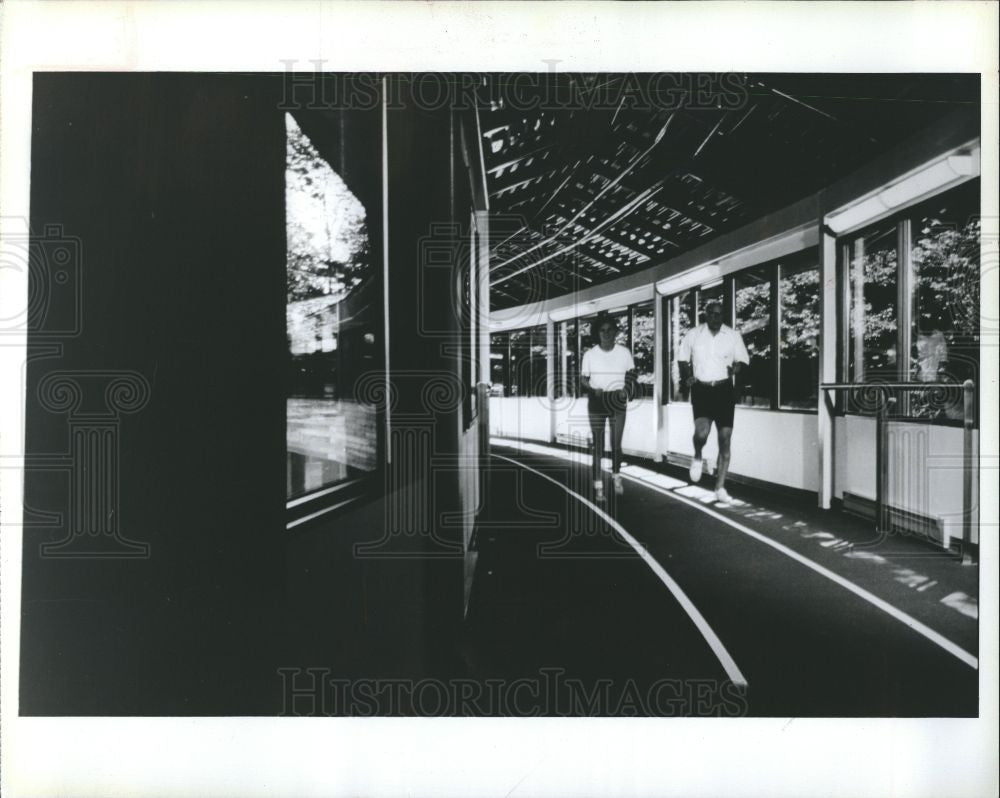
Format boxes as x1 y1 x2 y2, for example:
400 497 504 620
909 180 981 419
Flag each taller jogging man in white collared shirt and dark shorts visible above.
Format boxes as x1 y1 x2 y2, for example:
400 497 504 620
677 300 750 504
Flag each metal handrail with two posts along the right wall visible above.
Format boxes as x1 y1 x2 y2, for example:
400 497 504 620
819 380 976 557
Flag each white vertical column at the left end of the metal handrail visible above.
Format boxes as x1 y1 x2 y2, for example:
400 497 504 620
816 228 838 510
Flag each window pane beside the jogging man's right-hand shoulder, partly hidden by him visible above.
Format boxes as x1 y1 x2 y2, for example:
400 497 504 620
734 267 774 407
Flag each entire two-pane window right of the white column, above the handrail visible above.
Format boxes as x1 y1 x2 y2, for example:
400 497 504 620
841 180 981 420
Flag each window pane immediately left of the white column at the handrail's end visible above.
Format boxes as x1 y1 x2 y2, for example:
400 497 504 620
778 261 820 408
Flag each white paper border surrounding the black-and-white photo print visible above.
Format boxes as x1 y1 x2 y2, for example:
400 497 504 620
0 0 1000 798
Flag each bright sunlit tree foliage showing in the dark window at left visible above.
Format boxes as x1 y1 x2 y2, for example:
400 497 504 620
285 116 369 302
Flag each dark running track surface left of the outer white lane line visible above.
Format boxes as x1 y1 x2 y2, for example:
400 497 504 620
467 444 978 717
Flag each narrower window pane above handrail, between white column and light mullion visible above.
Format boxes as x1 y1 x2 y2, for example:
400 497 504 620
848 222 898 382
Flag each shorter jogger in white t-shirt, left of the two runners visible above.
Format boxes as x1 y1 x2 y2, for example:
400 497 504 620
580 316 635 500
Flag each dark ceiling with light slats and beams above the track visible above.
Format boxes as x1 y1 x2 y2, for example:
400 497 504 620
479 73 980 309
